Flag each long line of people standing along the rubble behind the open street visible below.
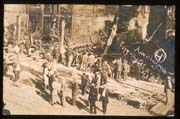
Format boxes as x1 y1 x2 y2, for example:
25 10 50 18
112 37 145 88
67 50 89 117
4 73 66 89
4 29 159 88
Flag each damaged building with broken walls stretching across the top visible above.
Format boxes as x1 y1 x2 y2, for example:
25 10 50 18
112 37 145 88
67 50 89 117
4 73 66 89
4 4 175 43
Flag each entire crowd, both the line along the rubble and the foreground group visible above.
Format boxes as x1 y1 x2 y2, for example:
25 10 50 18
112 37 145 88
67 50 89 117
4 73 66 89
4 24 173 114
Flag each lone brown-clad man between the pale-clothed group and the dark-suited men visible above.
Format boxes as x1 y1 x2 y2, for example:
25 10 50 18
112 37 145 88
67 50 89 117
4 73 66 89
72 77 79 105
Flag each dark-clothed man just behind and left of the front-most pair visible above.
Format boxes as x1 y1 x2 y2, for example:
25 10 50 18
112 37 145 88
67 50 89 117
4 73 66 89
81 73 88 95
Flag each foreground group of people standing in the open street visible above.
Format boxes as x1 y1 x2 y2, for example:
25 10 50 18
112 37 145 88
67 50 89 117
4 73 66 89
43 58 112 114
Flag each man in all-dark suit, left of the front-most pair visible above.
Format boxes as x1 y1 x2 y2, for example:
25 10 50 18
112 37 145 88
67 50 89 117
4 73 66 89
88 84 98 114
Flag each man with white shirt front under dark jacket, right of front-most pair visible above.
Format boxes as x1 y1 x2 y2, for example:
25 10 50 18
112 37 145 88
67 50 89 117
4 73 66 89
100 85 109 114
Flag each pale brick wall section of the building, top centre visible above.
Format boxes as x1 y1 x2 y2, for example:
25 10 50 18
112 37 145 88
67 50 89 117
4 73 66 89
72 5 115 44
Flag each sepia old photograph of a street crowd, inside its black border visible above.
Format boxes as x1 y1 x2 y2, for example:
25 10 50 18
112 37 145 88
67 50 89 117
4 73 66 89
2 4 176 116
